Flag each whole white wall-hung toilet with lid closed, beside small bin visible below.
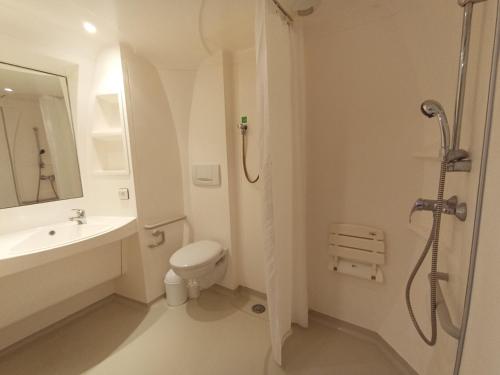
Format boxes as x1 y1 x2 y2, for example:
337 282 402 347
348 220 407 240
170 241 227 298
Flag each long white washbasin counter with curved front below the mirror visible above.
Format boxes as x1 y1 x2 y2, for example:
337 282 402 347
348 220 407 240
0 216 137 277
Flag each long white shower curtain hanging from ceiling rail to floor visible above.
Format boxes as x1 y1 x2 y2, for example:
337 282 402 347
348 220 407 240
256 0 308 365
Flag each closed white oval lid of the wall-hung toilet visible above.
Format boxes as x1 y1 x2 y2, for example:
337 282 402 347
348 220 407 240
170 241 222 268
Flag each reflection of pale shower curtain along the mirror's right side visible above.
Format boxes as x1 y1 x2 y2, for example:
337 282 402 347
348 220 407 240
39 96 82 199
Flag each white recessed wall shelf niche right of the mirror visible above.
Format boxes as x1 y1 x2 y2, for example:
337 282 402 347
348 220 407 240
90 93 129 176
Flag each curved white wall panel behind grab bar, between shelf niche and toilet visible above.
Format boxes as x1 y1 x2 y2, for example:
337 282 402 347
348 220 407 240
119 46 184 302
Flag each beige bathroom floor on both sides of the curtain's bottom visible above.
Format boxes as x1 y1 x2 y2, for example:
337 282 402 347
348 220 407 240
0 290 400 375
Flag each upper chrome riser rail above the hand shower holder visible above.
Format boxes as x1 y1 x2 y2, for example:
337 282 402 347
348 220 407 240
451 2 474 150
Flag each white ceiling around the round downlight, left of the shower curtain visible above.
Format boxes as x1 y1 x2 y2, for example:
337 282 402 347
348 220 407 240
0 0 255 69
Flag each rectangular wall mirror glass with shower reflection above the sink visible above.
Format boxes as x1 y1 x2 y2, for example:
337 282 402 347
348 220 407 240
0 63 83 208
